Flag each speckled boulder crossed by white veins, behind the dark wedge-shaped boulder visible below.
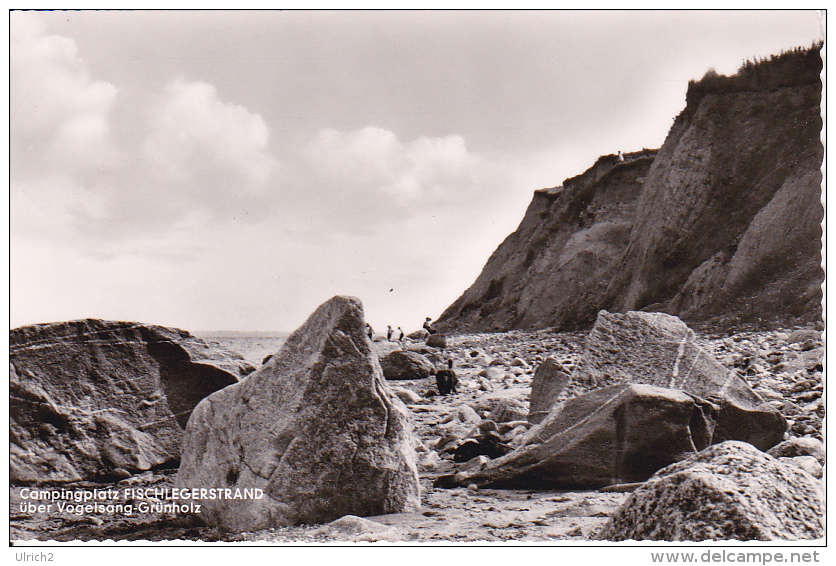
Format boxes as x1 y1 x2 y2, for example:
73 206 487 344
572 311 787 450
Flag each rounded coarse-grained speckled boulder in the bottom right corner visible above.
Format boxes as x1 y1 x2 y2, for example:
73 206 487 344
599 441 824 541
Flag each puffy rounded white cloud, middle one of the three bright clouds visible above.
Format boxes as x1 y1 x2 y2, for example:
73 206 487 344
70 78 278 238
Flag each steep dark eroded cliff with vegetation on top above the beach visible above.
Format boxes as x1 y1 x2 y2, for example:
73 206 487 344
438 50 824 338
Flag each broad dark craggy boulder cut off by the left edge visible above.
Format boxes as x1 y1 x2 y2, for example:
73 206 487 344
9 319 255 483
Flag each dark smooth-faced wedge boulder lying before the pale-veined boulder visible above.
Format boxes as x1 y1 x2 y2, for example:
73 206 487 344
436 384 716 489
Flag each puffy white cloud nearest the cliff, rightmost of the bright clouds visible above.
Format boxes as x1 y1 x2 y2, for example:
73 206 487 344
277 126 512 239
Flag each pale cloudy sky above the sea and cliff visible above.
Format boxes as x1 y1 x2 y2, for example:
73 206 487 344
10 11 822 332
